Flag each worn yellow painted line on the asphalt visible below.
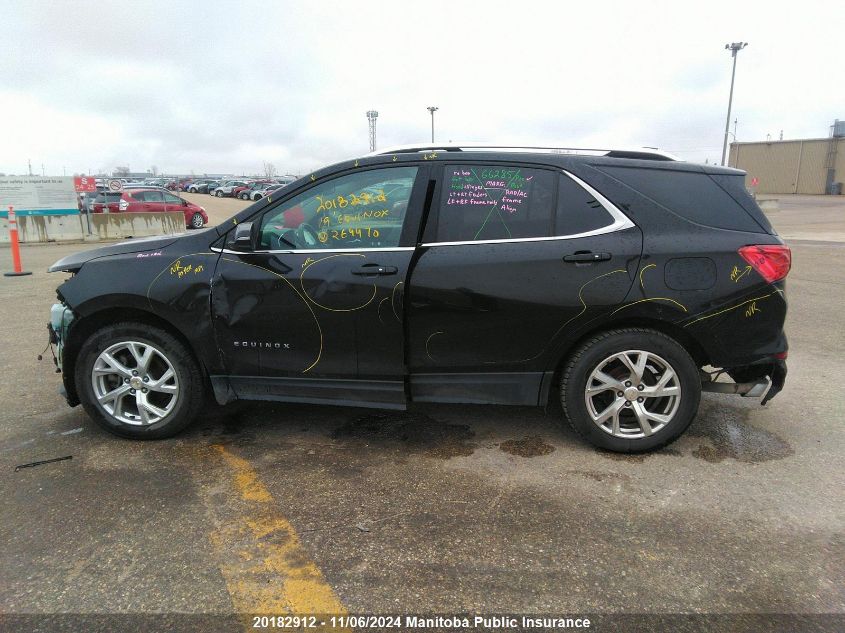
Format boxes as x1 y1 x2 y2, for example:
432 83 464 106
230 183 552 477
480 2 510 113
210 445 347 631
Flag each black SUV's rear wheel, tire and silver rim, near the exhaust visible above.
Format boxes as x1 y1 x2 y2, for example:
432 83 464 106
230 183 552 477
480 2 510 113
560 328 701 453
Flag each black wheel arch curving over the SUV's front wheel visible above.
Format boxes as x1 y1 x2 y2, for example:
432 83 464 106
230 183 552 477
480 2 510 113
62 308 209 405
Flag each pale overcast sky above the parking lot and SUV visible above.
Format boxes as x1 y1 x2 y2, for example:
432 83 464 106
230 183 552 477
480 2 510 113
0 0 845 175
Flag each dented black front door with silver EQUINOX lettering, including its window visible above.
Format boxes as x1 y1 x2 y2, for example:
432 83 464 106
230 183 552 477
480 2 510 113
212 164 428 406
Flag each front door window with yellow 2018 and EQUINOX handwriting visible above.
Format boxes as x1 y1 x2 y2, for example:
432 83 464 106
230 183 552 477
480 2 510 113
259 167 417 250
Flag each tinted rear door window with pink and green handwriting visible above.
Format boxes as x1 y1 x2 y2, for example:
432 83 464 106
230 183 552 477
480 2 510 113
436 165 556 242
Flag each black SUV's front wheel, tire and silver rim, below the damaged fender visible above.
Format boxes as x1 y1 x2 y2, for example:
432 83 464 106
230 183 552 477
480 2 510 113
74 322 204 440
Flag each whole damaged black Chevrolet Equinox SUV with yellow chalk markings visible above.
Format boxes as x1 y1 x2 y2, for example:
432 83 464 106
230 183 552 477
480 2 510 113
50 146 790 452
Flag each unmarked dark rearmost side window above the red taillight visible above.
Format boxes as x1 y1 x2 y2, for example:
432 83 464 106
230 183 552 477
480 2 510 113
599 167 762 233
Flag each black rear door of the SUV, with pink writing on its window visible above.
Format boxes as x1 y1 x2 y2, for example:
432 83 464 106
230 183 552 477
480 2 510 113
407 162 642 404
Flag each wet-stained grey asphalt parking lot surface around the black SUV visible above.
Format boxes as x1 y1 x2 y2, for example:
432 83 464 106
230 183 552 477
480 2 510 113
0 195 845 631
